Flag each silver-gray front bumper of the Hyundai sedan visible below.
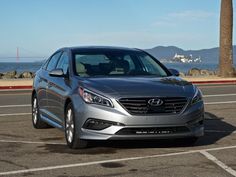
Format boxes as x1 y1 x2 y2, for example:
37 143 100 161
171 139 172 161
74 97 204 140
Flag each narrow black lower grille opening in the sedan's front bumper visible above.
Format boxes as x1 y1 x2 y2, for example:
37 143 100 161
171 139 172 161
116 126 189 135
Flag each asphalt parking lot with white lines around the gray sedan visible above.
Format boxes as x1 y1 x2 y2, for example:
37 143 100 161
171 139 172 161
0 85 236 177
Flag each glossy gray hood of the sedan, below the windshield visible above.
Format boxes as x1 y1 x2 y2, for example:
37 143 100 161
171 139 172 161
79 76 195 98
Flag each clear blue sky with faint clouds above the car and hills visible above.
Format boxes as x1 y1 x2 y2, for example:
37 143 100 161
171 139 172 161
0 0 235 62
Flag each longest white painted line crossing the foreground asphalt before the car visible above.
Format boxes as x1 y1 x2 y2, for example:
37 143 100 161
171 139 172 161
0 146 236 176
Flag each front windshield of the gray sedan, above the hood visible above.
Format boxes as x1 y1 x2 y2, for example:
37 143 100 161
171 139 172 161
73 51 168 77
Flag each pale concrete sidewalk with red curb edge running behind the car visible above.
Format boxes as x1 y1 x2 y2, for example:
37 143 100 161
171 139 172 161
0 76 236 90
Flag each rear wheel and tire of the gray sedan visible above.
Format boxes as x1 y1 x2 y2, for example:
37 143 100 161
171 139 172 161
32 95 51 129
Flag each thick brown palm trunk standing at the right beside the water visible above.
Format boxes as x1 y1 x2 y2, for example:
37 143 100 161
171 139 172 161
219 0 234 77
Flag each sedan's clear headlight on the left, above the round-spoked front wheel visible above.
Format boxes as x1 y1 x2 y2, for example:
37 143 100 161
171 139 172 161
79 87 113 107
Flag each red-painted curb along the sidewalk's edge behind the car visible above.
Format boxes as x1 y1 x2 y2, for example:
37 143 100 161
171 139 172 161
0 80 236 90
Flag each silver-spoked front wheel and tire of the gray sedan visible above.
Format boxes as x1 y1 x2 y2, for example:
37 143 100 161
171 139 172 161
65 103 88 149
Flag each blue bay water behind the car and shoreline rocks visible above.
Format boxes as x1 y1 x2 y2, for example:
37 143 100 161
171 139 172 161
0 62 236 73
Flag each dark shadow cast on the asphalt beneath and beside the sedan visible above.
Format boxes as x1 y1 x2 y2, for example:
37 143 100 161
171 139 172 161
40 112 236 155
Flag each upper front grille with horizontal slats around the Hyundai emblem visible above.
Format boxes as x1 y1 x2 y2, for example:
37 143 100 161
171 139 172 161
119 97 188 115
